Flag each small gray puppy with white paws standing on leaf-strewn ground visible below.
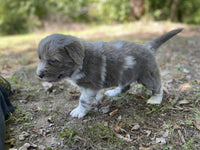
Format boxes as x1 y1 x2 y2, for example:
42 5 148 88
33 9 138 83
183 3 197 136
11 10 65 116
36 29 183 118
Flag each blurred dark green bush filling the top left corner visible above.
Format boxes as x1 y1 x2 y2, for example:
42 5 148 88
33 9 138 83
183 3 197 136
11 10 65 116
0 0 46 34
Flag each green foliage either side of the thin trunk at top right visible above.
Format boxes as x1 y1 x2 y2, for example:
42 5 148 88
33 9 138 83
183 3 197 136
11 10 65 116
146 0 200 24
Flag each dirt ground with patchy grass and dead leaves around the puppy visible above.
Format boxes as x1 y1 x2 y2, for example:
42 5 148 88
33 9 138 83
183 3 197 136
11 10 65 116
0 23 200 150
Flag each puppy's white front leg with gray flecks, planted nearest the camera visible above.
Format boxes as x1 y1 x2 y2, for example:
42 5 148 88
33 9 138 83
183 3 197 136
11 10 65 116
70 88 98 118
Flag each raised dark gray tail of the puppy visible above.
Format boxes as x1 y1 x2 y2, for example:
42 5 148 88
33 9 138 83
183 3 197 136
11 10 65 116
145 28 183 52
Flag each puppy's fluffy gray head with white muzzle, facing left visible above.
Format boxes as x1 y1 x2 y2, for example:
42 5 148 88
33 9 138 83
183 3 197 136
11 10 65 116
36 34 84 82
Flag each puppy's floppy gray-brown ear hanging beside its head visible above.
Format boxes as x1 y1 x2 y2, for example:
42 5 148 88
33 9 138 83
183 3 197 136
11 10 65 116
64 41 85 65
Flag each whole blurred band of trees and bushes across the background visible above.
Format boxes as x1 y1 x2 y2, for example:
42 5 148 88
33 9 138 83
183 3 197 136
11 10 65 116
0 0 200 34
